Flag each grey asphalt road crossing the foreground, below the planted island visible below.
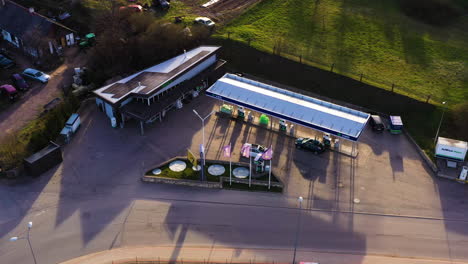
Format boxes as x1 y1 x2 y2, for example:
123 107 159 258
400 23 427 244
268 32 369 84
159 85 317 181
0 187 468 264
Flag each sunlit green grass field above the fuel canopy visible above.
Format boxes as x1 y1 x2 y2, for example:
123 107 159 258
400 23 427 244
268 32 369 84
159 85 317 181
218 0 468 105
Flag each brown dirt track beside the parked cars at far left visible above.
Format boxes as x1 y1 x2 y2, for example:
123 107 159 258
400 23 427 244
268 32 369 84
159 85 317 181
0 49 86 141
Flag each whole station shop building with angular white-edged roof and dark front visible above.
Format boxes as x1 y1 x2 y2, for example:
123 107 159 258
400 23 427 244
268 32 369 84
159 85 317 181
94 46 225 134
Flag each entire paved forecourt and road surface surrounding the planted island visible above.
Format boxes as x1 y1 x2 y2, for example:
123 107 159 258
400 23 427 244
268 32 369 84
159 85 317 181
0 97 468 263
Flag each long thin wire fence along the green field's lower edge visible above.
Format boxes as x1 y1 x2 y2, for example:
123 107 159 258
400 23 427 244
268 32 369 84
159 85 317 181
224 32 456 105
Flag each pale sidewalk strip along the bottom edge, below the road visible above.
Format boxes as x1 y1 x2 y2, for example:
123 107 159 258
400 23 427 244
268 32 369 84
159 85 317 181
62 246 467 264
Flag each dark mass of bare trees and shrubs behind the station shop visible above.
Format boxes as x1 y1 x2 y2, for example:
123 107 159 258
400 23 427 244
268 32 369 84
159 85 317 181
89 11 210 86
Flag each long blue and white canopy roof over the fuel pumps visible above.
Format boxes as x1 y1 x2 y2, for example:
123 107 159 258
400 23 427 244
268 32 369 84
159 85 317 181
206 73 370 141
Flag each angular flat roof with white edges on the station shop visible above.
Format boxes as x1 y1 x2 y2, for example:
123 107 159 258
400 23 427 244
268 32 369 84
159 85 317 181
94 46 220 103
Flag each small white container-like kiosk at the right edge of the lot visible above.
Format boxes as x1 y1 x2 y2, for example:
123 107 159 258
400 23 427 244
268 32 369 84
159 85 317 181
435 137 468 167
